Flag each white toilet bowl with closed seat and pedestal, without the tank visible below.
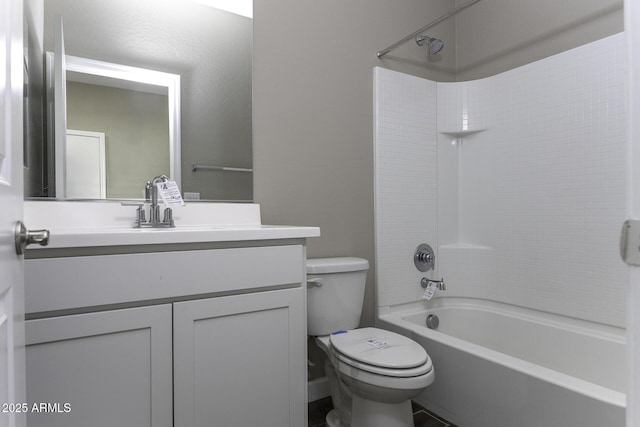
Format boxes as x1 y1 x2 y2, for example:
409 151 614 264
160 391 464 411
316 328 435 427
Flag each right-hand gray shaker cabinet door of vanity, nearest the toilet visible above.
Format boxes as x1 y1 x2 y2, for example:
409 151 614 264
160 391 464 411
174 288 307 427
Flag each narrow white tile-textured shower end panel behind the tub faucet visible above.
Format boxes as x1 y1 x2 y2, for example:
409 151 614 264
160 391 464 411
374 68 437 305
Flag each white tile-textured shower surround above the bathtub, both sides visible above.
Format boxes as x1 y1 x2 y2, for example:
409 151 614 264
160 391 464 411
374 34 628 327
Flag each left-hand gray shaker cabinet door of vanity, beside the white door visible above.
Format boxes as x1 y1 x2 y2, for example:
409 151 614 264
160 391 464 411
26 304 173 427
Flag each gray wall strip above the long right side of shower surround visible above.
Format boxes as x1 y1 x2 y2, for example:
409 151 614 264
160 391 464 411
456 0 623 80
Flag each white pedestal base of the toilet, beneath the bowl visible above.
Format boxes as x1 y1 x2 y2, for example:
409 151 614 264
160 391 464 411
351 393 414 427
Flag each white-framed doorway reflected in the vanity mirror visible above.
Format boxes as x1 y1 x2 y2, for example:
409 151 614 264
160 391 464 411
47 55 180 199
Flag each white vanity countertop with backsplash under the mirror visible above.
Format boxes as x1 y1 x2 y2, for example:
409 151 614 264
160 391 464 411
25 201 320 251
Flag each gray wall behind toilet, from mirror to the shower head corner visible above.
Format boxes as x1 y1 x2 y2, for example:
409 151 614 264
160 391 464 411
254 0 455 324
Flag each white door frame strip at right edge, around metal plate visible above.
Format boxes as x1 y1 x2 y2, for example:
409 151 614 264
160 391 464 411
624 0 640 427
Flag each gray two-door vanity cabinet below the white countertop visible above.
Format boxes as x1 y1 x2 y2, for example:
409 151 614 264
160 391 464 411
25 239 307 427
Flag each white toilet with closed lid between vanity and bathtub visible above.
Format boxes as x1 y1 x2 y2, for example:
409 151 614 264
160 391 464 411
307 257 435 427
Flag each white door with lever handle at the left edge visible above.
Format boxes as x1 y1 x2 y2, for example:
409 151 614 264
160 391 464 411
0 0 26 427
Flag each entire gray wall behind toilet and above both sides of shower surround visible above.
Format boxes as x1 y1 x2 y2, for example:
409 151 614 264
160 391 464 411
253 0 623 332
